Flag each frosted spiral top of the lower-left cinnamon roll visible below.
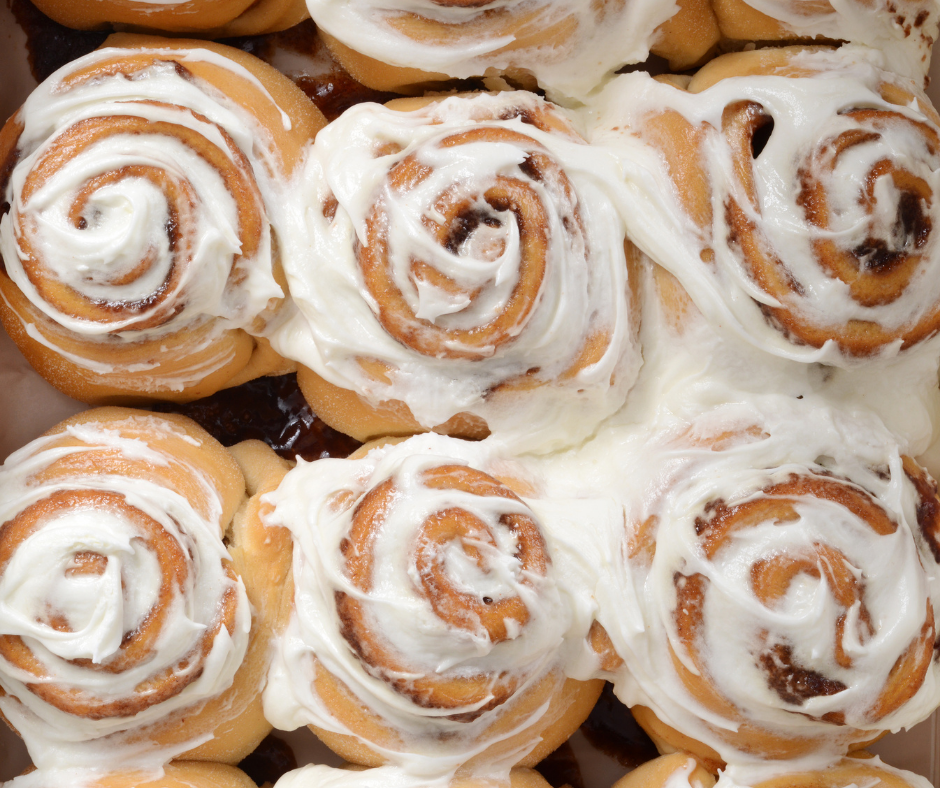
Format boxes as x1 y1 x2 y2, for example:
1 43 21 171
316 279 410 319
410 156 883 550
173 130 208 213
0 416 251 768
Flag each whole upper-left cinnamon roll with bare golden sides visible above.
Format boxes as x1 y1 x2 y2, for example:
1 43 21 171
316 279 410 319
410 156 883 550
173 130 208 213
0 36 322 403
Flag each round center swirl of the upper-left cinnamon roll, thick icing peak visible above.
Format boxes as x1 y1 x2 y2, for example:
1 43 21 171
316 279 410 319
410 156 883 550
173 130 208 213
12 102 266 332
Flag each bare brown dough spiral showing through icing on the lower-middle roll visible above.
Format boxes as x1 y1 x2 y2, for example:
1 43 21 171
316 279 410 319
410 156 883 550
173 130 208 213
336 458 550 719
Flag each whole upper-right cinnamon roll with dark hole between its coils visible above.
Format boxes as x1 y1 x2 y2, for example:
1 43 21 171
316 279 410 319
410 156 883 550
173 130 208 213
592 48 940 365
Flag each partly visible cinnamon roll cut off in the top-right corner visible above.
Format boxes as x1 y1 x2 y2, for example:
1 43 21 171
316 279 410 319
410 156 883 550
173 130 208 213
712 0 940 86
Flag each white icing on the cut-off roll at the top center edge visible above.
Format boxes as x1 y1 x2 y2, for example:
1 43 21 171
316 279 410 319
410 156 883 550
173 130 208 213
307 0 678 98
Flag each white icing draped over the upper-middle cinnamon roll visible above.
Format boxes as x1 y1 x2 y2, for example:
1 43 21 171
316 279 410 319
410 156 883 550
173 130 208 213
272 93 640 451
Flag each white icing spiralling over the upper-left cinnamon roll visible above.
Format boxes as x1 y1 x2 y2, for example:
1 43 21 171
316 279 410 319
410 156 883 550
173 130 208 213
0 42 292 390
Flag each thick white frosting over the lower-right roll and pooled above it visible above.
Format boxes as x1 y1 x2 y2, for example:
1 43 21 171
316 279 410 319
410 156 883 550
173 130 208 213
506 258 940 771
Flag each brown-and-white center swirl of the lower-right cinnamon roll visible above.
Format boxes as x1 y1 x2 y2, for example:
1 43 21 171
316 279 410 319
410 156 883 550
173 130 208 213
670 474 934 725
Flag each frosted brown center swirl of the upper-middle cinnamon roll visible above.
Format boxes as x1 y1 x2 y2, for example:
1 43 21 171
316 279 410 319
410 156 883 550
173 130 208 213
358 127 587 360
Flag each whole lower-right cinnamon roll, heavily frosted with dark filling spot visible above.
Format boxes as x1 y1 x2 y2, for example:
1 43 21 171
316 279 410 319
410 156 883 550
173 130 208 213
598 404 940 769
